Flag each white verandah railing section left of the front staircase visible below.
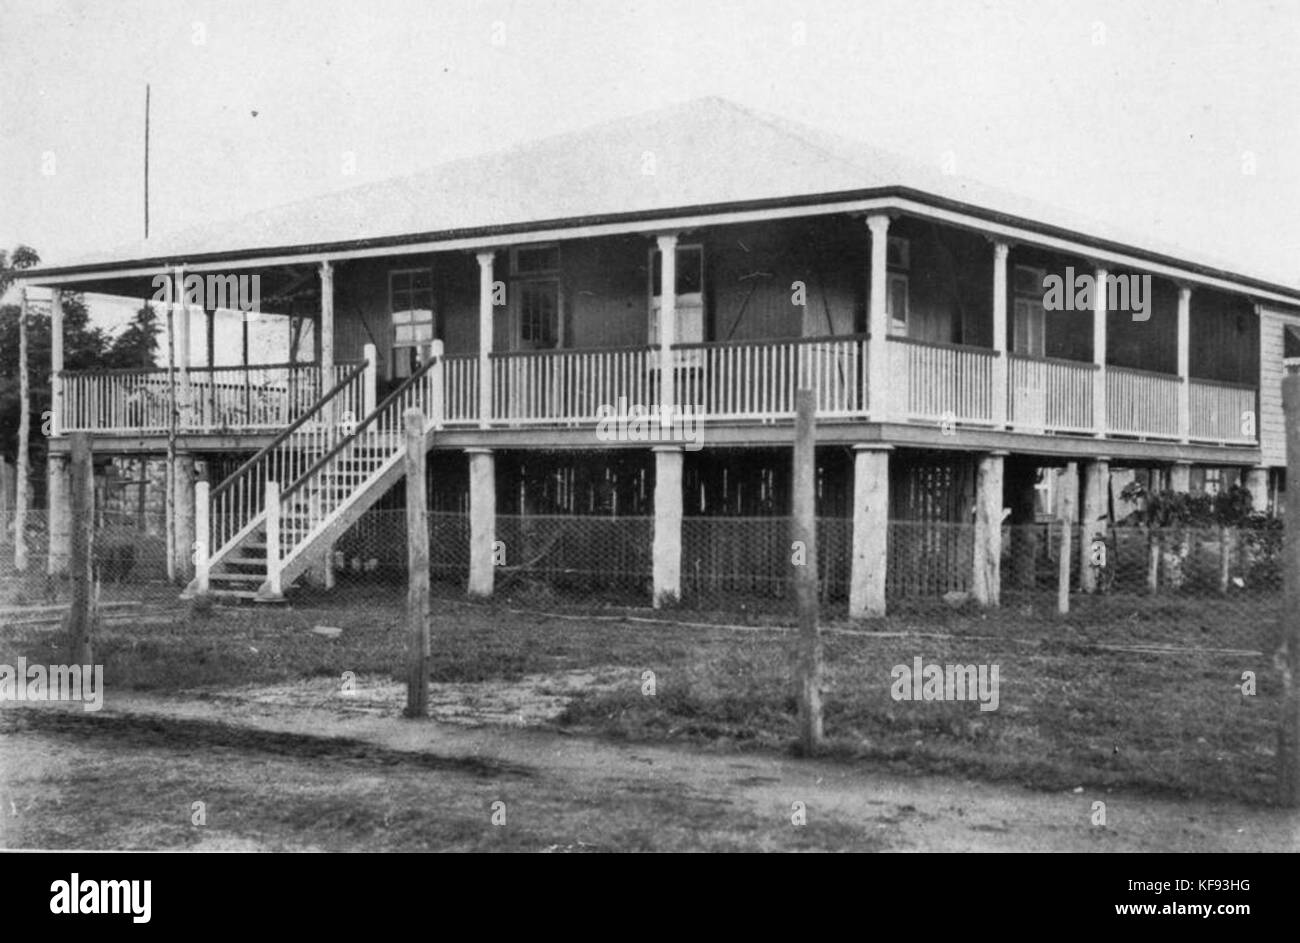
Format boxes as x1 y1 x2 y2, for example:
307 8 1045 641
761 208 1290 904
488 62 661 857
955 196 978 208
60 363 356 434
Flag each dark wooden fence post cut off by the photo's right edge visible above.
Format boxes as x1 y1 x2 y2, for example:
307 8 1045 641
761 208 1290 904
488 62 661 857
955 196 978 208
1278 373 1300 808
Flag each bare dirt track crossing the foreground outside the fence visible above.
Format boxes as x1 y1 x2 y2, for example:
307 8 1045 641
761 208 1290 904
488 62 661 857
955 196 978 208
0 669 1300 852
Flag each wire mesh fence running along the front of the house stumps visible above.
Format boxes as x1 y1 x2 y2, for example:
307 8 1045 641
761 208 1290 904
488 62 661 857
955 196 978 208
0 509 1283 629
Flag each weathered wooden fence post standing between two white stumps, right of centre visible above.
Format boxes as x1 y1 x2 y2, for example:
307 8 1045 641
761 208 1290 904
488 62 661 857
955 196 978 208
790 389 823 756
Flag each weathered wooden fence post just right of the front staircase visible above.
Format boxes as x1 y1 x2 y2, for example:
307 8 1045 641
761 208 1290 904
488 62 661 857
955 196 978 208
403 408 432 717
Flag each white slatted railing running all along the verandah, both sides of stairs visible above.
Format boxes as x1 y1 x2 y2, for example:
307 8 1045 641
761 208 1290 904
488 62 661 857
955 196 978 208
61 334 1257 445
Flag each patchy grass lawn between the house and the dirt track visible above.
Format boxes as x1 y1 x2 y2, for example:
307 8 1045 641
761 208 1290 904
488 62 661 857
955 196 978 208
0 577 1281 804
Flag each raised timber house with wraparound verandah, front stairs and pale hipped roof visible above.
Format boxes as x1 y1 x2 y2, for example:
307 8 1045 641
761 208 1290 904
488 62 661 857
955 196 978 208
17 99 1300 618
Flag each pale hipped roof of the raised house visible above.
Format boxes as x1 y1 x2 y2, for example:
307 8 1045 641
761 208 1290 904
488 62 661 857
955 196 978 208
34 98 1300 292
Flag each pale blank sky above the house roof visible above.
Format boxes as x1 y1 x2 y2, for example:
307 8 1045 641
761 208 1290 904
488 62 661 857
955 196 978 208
0 0 1300 338
